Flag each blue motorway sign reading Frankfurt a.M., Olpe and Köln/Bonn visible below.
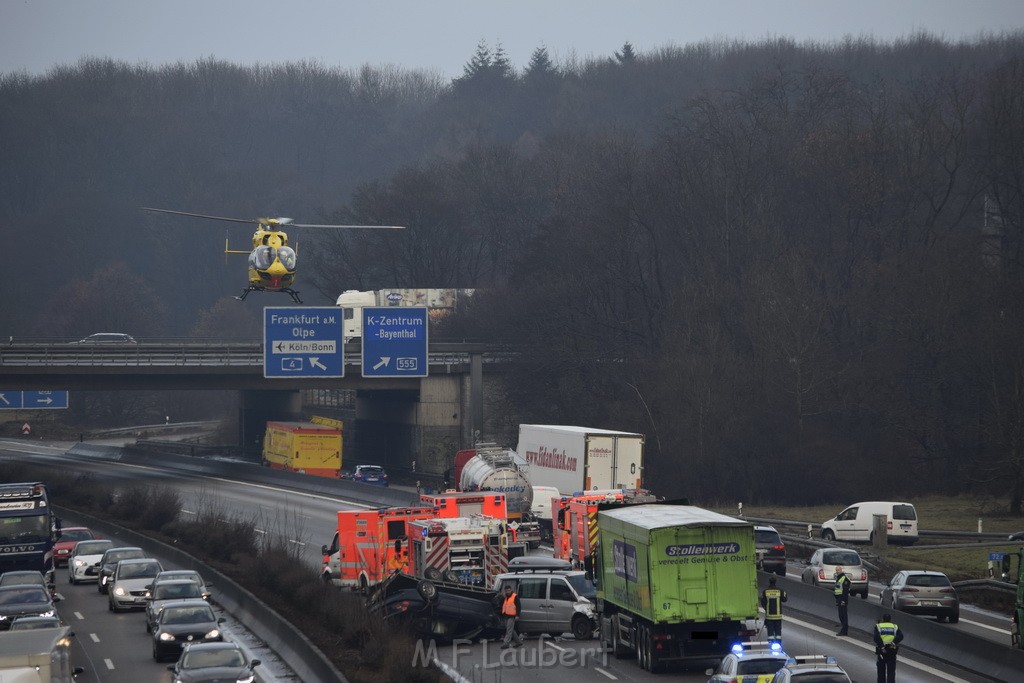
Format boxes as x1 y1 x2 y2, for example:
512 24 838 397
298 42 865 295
263 306 345 379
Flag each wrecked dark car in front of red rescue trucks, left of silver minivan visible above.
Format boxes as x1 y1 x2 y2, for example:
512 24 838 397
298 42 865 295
368 573 504 642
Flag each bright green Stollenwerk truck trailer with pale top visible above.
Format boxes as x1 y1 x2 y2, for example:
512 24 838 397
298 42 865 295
596 504 759 672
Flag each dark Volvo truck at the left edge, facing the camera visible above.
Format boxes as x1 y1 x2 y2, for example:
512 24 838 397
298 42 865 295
0 482 60 580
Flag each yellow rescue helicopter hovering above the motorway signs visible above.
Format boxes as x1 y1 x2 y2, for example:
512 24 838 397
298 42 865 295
142 207 404 304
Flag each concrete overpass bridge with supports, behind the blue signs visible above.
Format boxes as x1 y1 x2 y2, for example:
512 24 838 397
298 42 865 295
0 339 513 474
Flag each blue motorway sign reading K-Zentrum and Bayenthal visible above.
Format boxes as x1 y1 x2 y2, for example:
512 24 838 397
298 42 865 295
362 306 427 377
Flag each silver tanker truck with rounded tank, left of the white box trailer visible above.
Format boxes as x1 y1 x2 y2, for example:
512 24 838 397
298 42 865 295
458 443 541 548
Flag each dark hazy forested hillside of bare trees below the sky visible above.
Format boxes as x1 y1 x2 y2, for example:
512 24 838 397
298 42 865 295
6 34 1024 512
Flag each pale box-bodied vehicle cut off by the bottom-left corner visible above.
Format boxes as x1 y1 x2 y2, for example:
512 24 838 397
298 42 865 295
0 626 84 683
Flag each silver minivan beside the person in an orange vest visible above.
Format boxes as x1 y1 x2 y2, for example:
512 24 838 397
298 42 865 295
495 558 598 640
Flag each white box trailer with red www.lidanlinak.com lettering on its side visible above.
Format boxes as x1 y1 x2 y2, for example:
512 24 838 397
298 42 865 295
516 425 644 496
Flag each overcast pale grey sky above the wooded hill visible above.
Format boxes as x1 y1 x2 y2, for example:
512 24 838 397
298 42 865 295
0 0 1024 77
